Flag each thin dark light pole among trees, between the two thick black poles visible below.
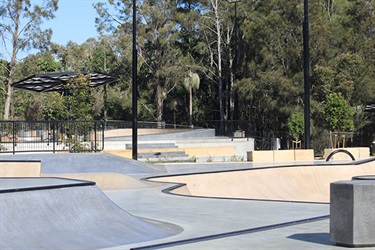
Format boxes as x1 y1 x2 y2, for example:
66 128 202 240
228 0 241 136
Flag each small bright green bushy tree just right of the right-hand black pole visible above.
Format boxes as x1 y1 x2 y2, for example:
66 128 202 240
324 93 354 132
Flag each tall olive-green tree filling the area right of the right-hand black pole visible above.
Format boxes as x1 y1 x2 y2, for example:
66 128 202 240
310 0 375 146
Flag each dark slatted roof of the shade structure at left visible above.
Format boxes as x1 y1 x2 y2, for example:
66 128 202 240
12 71 118 92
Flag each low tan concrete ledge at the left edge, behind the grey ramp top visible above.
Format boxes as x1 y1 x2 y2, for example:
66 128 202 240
0 161 42 177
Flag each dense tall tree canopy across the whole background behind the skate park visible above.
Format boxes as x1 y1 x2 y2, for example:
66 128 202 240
0 0 375 148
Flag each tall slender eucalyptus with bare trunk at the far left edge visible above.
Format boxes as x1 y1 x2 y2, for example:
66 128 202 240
0 0 58 120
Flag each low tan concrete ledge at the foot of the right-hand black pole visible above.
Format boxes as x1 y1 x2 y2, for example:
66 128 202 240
247 149 314 162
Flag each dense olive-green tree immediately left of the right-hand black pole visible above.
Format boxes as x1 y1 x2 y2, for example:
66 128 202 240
236 0 303 136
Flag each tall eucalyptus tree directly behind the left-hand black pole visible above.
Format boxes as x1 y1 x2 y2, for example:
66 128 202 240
96 0 184 122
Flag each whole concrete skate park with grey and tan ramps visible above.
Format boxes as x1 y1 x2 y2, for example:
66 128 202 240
0 128 375 249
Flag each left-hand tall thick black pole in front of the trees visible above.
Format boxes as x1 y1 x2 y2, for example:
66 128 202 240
132 0 138 160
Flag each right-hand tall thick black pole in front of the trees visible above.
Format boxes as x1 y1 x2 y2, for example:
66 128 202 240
303 0 310 149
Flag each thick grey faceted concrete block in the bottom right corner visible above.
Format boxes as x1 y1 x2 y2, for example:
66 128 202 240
330 180 375 247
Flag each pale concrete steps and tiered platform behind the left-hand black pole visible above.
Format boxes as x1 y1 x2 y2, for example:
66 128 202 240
104 129 254 162
